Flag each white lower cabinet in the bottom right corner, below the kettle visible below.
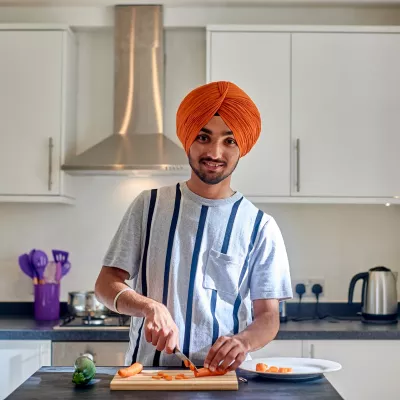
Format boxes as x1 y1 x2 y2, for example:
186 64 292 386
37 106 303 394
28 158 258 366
303 340 400 400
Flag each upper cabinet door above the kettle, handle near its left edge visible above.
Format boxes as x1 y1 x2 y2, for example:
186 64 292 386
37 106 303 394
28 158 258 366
292 33 400 197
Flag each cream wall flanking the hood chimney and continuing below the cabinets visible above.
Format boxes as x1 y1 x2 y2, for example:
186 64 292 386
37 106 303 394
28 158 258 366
0 6 400 301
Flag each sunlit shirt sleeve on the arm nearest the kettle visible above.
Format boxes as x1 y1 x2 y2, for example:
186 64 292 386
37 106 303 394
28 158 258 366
250 217 293 301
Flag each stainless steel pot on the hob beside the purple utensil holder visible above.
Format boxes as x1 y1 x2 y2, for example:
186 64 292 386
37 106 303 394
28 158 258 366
68 291 111 318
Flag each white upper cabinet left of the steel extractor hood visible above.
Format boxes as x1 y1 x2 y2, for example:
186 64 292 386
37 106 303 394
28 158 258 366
0 25 76 202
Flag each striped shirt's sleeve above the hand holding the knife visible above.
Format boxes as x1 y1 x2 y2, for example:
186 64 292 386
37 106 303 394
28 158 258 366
103 192 145 280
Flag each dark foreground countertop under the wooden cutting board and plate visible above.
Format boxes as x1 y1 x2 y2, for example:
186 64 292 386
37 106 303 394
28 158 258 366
7 367 342 400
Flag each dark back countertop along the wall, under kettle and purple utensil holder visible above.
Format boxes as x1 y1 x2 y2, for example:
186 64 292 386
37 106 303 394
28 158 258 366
0 317 400 341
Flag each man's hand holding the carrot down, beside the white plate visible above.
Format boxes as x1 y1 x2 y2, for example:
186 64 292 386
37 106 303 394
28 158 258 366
204 336 249 371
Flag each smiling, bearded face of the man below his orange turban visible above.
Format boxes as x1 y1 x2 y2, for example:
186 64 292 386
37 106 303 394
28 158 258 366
189 116 240 185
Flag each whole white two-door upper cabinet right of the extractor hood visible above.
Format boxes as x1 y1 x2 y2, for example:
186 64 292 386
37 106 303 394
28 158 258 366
207 26 400 204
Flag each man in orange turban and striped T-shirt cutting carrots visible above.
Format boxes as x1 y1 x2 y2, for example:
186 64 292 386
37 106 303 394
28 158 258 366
96 81 292 371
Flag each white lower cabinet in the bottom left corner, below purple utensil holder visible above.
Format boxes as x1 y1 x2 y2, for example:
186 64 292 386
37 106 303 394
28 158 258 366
0 340 51 399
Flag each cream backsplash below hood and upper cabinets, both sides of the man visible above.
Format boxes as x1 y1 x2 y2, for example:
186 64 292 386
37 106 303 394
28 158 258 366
0 177 400 302
